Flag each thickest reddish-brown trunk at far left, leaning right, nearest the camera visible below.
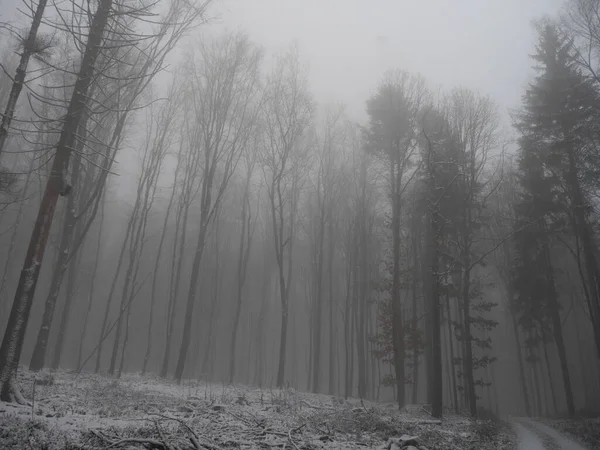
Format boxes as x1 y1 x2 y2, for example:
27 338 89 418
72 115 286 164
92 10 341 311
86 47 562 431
0 0 113 402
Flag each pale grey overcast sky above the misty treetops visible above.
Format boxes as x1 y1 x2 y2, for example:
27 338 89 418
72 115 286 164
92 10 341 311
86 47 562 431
214 0 563 120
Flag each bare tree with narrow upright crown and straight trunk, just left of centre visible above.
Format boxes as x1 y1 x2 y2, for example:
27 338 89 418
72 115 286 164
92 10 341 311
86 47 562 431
261 48 313 387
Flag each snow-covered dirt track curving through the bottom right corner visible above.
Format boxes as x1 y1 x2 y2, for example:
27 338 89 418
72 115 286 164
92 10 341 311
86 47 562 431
513 418 587 450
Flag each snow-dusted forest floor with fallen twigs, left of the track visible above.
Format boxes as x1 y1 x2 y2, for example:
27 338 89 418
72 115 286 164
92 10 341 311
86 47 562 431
0 371 515 450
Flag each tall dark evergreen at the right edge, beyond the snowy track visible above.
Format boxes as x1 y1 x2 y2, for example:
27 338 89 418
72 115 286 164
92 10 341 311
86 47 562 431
514 23 600 414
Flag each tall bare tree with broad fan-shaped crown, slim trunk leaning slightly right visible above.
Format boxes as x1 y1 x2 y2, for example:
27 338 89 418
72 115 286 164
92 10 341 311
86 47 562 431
175 34 262 381
